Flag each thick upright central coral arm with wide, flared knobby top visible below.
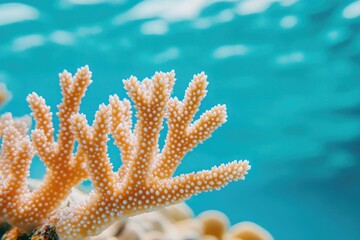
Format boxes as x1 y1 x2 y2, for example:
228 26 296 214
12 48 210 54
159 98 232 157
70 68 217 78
124 72 174 186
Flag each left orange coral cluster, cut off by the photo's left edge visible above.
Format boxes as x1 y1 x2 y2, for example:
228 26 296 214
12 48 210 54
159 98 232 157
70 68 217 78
0 67 91 232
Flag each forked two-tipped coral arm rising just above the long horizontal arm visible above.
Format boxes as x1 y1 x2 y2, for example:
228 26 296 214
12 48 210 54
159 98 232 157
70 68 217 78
152 73 227 179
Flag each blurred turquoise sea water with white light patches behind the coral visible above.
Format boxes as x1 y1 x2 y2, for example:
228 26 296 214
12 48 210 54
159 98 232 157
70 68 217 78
0 0 360 240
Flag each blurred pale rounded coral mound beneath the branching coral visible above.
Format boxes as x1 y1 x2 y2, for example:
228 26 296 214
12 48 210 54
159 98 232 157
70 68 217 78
86 203 274 240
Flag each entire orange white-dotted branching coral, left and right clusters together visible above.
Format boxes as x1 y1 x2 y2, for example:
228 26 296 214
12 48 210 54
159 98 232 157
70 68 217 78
0 66 250 239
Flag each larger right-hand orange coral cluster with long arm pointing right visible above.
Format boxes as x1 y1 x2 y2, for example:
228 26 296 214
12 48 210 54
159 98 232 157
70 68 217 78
56 68 250 239
